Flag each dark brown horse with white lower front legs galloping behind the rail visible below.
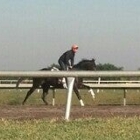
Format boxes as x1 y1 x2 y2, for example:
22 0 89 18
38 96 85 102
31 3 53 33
16 59 96 106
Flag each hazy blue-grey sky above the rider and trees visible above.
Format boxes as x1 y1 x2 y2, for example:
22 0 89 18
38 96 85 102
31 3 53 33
0 0 140 70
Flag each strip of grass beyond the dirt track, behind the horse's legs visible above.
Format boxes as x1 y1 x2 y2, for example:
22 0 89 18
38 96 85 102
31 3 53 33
0 89 140 105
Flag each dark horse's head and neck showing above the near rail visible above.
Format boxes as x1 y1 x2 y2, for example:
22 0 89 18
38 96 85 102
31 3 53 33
74 59 96 70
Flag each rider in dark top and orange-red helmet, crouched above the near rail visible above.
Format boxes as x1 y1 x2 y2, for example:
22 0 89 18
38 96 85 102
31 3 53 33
58 44 78 70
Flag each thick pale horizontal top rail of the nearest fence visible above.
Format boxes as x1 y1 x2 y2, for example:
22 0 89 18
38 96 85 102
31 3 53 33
0 71 140 77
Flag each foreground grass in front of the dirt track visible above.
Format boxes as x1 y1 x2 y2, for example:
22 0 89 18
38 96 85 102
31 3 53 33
0 117 140 140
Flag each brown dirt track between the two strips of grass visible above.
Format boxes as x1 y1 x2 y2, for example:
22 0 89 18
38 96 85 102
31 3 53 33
0 105 140 120
